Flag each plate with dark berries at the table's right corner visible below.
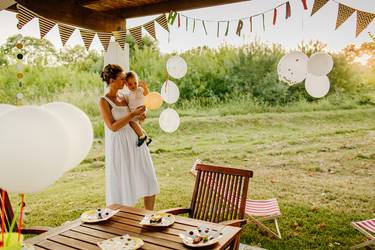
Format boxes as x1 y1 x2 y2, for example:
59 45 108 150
179 226 222 247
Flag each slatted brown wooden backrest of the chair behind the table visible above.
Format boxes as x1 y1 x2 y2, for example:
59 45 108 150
189 164 253 223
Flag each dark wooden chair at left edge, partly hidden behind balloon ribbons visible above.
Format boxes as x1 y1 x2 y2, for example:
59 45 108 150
0 189 50 234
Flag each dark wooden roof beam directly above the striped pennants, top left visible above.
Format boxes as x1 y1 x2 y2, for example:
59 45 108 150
17 0 125 32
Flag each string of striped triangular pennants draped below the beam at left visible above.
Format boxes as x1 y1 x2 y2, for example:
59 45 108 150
16 4 169 51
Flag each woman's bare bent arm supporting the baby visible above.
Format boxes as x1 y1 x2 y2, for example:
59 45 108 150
99 98 145 132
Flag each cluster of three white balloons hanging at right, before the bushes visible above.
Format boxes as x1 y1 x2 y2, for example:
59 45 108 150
277 51 333 98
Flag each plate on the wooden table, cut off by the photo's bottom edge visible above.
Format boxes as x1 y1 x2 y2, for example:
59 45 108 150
98 234 144 250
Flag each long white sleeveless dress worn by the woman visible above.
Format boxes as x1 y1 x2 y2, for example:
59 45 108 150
104 97 160 206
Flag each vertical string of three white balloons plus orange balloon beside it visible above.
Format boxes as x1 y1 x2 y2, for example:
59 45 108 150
145 56 187 133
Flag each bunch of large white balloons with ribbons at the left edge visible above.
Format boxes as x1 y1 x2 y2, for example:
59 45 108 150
0 102 93 246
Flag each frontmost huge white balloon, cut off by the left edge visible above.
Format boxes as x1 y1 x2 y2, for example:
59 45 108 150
0 106 70 193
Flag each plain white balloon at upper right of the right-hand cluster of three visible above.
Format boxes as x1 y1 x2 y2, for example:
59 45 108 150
307 52 333 76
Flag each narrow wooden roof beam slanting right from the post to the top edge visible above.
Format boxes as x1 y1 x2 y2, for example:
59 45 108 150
108 0 250 18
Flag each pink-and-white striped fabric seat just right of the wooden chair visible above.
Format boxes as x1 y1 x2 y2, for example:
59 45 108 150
245 198 281 216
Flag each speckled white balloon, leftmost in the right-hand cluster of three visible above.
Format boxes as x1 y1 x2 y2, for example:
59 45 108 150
277 51 308 85
